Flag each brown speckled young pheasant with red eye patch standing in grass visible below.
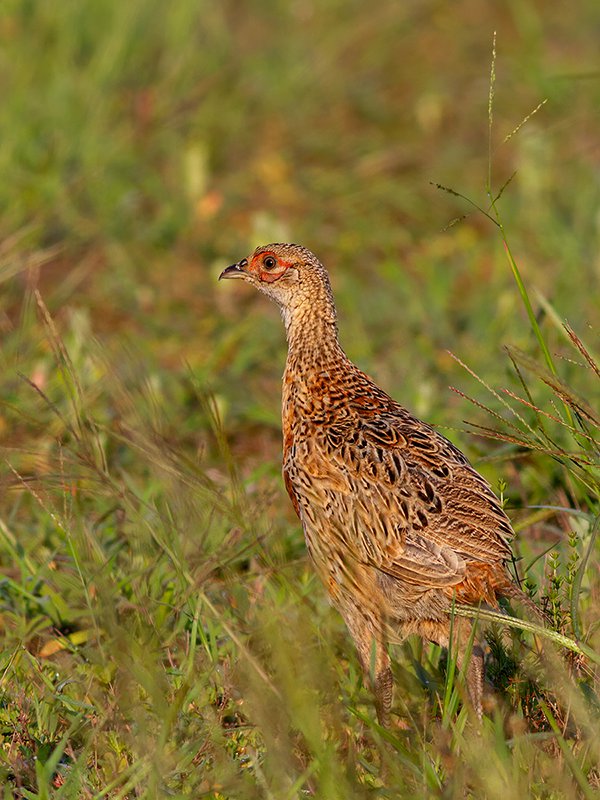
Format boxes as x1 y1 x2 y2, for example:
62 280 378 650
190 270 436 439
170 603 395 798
220 244 524 725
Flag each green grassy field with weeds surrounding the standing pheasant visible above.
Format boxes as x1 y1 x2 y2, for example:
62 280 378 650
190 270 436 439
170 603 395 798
0 0 600 800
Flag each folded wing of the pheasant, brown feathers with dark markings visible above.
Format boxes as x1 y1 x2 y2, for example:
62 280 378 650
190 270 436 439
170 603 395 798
298 407 512 586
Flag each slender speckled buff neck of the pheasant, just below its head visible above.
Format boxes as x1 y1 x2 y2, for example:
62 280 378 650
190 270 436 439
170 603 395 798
282 287 345 371
